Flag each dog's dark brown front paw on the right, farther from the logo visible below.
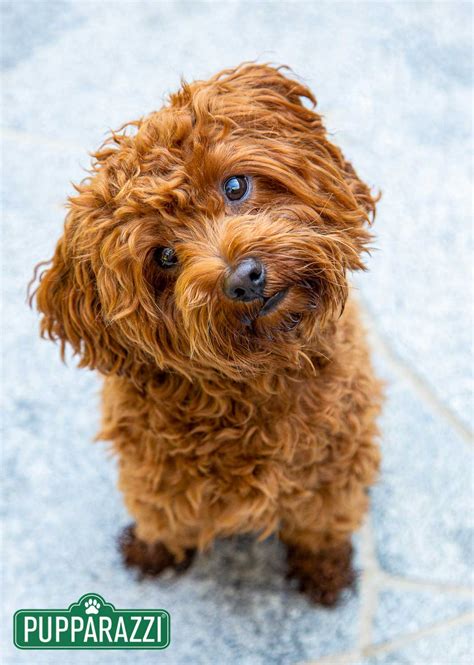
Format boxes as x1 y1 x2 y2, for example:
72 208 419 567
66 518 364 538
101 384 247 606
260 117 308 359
287 543 356 607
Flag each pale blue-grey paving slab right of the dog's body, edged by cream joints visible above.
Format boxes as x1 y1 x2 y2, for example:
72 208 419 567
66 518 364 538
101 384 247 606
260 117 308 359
372 362 474 585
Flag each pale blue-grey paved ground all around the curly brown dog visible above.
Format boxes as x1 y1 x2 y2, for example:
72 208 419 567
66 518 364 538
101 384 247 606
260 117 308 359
0 0 474 665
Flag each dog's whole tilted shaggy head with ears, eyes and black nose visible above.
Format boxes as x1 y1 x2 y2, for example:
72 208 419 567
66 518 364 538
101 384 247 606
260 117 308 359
32 64 374 379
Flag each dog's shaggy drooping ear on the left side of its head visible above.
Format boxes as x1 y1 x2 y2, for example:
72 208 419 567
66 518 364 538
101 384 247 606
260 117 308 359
30 185 128 374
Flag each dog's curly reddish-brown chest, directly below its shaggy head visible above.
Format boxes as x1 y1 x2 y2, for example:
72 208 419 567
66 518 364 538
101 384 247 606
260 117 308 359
105 374 322 538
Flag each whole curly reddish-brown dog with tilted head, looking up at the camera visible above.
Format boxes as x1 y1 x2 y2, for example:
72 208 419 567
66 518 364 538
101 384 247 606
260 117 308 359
31 64 380 605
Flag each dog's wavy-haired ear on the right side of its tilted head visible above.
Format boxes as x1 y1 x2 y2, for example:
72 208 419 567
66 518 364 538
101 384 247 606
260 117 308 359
217 63 378 270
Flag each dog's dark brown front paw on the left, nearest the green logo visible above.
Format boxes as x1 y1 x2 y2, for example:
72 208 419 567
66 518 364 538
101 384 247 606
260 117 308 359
119 524 194 577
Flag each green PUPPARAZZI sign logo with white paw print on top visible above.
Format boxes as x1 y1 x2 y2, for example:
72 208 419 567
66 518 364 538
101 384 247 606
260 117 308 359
13 593 170 649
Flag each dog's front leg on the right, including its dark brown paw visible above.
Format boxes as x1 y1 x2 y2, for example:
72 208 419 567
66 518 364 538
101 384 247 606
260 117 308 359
280 484 367 606
